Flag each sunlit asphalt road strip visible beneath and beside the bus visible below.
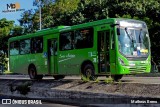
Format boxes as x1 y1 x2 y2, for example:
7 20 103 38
0 75 160 84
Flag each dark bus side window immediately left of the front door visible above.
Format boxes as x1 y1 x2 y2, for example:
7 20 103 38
74 28 93 49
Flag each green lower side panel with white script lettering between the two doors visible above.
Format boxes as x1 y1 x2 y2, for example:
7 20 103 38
58 45 97 75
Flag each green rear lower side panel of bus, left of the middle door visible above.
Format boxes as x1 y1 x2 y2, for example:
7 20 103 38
10 54 46 74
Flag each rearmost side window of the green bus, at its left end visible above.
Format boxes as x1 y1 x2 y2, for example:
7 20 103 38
10 41 19 55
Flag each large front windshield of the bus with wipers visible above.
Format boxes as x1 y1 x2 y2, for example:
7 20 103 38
118 27 150 57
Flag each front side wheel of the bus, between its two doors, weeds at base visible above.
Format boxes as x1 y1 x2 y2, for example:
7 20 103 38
82 64 97 81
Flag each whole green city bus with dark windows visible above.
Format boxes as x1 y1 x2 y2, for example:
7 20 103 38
8 18 151 81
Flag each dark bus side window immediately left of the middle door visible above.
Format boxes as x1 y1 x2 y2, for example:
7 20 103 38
31 37 43 53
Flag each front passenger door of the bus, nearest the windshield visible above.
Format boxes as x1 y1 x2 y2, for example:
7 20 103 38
96 24 116 74
